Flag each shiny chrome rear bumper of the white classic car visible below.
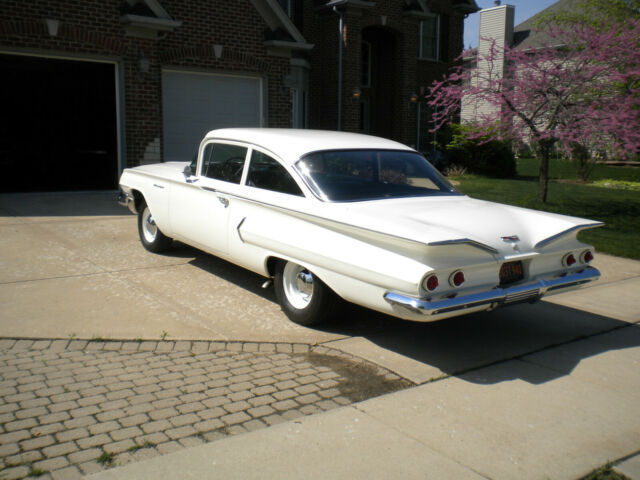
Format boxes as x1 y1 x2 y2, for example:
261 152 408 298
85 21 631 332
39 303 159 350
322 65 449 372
384 267 600 316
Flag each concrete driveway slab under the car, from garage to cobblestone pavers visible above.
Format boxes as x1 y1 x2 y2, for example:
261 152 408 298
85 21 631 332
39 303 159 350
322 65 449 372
0 192 640 383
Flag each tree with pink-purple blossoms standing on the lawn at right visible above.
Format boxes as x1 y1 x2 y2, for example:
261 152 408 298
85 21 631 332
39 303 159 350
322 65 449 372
429 19 640 202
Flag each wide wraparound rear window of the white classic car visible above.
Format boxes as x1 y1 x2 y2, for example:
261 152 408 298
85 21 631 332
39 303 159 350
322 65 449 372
296 150 458 202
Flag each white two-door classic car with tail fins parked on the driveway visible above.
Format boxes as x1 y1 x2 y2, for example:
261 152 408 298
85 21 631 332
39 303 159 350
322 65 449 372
119 128 602 325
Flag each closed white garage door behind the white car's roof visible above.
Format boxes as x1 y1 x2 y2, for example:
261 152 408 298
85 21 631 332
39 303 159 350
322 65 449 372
162 71 262 162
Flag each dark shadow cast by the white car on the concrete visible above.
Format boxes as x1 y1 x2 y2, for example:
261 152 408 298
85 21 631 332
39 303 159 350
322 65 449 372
178 248 640 384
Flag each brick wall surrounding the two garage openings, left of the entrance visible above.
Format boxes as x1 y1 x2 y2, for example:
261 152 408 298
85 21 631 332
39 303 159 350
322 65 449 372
0 0 290 166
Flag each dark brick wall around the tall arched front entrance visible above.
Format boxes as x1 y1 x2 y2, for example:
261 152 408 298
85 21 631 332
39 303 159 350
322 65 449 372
303 0 464 145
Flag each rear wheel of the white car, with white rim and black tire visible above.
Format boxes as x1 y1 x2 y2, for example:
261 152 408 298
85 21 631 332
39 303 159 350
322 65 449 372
274 262 338 326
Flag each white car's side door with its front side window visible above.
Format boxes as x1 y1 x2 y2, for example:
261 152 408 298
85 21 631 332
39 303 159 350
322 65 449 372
170 141 248 255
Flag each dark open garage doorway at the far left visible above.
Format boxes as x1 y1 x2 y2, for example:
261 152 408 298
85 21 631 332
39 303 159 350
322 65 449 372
0 54 118 192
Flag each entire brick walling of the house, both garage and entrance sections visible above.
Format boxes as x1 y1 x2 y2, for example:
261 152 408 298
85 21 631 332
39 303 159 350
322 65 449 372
0 0 470 172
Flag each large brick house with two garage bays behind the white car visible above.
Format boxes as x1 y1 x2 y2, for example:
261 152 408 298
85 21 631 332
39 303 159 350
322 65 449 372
0 0 478 191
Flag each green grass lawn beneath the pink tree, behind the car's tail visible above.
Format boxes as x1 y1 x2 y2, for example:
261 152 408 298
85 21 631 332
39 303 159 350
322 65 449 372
455 159 640 260
